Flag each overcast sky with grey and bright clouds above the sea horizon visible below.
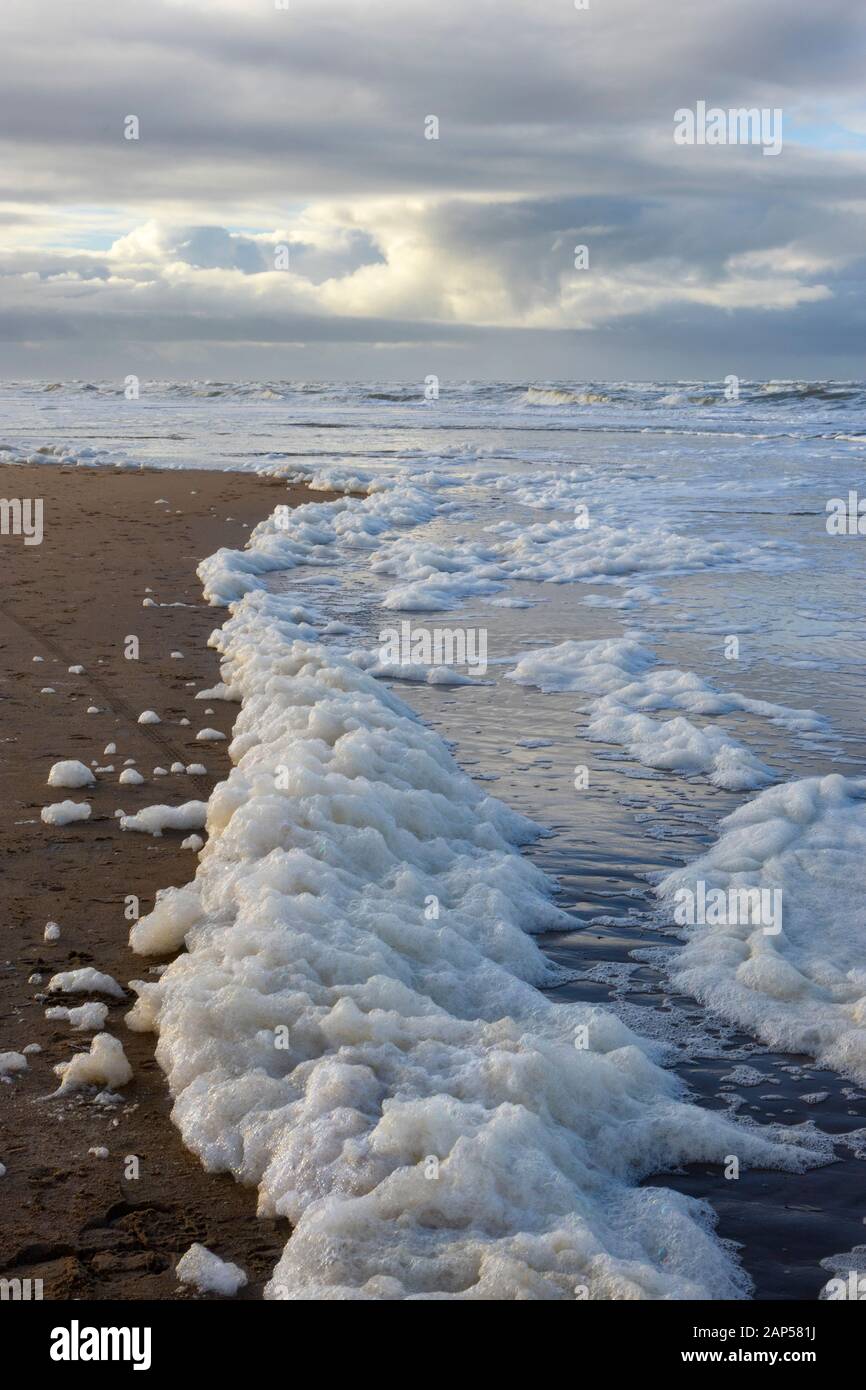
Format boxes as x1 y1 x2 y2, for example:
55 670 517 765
0 0 866 379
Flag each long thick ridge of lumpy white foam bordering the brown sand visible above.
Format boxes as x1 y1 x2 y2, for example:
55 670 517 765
131 556 816 1300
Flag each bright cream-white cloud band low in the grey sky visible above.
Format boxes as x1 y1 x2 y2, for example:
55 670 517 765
6 199 831 329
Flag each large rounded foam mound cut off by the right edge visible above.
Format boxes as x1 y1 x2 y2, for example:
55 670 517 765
656 774 866 1084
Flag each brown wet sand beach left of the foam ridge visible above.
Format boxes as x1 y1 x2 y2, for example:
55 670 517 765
0 466 335 1298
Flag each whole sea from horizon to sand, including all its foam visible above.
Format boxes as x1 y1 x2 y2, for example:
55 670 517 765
6 382 866 1298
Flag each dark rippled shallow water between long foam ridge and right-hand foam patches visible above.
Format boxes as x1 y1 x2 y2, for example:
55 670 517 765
386 603 866 1300
